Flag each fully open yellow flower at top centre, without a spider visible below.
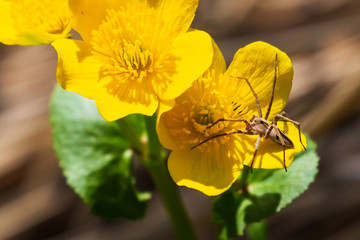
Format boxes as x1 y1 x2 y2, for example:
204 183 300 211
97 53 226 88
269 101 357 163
53 0 213 121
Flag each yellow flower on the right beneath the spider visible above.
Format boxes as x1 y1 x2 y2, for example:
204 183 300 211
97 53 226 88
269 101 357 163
157 42 306 196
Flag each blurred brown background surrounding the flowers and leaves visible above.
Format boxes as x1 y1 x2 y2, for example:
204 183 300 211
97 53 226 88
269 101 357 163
0 0 360 240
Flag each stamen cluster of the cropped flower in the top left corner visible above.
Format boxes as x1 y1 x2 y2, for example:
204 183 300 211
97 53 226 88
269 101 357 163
11 0 70 34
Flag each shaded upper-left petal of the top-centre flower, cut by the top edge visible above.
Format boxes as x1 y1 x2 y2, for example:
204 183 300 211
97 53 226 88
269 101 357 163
69 0 128 41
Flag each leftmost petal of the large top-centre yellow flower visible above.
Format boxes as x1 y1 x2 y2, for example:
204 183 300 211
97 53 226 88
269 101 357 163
52 39 102 99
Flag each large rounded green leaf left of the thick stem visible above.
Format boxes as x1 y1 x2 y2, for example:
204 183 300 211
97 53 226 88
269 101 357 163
50 86 150 220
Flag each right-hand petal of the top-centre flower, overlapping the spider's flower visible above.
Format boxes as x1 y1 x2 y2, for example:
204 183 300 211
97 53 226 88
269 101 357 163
153 31 213 100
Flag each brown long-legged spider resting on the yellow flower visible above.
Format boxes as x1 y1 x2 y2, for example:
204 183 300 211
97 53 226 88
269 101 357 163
191 54 306 172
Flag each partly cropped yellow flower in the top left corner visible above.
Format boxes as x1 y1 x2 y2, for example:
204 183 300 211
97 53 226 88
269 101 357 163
0 0 71 45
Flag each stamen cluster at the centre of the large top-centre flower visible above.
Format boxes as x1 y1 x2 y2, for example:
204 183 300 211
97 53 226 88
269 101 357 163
91 3 169 83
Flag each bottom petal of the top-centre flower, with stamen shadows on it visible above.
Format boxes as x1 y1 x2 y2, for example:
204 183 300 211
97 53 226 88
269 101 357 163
95 76 158 121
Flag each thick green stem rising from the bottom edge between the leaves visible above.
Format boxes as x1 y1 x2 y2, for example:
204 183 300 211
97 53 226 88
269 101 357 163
142 116 196 240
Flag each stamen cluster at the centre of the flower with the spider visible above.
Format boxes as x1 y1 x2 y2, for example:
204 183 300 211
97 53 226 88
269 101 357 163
165 72 249 151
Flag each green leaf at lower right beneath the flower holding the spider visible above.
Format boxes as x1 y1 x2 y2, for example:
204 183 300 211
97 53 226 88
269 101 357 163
213 137 319 239
